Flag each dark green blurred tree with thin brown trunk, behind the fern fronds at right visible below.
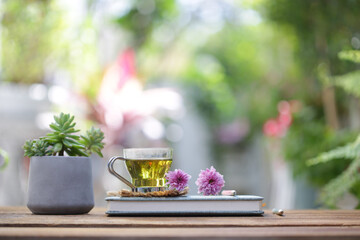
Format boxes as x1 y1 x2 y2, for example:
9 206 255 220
260 0 360 207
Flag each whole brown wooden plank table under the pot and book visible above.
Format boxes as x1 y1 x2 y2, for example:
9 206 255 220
0 207 360 239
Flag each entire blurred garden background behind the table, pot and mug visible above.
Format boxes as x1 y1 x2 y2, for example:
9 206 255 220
0 0 360 209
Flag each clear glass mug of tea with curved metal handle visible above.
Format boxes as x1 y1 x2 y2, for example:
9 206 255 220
108 148 173 192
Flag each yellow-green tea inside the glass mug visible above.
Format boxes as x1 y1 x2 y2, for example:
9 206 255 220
125 158 172 187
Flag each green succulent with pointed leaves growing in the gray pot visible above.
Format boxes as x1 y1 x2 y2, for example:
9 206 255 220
23 113 104 157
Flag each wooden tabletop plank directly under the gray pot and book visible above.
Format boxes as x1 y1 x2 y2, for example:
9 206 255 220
0 207 360 228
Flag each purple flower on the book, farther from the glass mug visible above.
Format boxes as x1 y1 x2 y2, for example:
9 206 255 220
195 166 225 196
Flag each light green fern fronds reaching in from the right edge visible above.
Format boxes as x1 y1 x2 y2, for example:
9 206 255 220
307 51 360 209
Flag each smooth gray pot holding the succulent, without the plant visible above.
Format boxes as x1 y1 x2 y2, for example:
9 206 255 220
27 156 94 214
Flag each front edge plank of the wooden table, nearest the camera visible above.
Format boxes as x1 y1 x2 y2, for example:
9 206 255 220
0 227 360 239
